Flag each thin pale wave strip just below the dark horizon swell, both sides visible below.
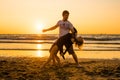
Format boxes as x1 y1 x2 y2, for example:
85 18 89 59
0 40 120 45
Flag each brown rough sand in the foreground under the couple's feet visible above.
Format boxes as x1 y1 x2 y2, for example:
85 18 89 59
0 57 120 80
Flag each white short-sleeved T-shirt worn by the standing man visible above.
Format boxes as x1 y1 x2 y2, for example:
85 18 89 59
57 20 73 37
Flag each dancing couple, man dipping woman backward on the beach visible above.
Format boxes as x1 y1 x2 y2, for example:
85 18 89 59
42 10 83 68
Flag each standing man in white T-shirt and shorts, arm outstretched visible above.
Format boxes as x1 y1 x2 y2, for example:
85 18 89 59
43 10 80 67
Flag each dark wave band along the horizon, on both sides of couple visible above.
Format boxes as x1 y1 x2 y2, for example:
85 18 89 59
0 34 120 41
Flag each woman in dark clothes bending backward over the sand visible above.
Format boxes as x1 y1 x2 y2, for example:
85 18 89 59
43 30 83 67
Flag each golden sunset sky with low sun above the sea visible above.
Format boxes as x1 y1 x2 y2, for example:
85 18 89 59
0 0 120 34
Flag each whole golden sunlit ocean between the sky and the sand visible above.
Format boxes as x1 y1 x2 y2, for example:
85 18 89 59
0 34 120 59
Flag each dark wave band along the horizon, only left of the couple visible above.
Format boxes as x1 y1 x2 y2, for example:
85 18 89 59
0 34 57 40
